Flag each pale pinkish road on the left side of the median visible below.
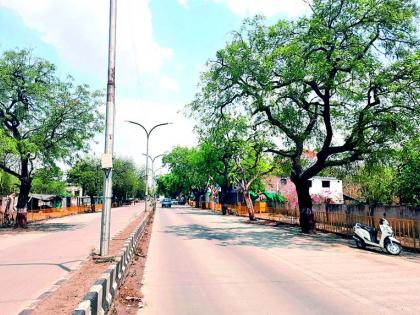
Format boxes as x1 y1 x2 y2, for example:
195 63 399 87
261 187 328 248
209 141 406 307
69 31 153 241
0 205 143 315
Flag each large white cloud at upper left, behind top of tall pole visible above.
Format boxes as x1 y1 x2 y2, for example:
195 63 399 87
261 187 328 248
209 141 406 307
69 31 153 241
0 0 173 88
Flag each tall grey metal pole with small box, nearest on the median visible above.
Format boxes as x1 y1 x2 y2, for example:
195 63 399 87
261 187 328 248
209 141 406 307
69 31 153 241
100 0 117 257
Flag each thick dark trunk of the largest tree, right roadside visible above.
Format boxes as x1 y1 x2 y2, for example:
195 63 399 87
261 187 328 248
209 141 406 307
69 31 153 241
293 180 316 234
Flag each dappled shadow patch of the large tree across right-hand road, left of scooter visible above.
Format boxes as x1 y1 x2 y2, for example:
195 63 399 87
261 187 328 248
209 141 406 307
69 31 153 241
164 222 348 250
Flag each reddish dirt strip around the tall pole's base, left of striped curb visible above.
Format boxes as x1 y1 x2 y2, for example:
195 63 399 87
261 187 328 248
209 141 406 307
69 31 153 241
30 212 145 315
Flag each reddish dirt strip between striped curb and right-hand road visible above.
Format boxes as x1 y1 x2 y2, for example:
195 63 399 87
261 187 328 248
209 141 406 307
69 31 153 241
109 216 153 315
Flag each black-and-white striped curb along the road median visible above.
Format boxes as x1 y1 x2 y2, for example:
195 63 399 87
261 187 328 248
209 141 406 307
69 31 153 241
72 212 151 315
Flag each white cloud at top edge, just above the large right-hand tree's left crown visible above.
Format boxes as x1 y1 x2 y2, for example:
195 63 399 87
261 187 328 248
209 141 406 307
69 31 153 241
178 0 308 18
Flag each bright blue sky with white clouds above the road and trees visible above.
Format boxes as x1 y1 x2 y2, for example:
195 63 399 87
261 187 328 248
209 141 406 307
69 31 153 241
0 0 307 173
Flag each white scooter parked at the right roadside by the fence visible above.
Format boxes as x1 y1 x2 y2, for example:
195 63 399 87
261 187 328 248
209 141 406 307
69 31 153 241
353 219 402 255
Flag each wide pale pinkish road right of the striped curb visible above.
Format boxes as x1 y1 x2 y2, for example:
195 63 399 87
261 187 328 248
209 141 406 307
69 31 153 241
139 208 420 315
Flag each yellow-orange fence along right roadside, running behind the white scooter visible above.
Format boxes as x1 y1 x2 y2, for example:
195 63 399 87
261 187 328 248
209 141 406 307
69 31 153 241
190 202 420 251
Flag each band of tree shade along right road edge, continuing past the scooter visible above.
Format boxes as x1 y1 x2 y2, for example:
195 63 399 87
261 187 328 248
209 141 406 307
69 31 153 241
164 208 420 263
